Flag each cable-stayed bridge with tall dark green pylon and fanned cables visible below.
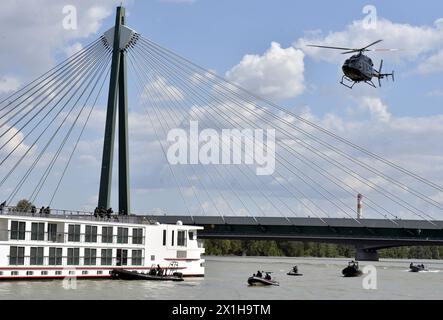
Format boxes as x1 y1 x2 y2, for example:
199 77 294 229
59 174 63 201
0 7 443 259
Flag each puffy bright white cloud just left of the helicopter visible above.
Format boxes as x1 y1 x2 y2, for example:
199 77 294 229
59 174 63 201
226 42 305 99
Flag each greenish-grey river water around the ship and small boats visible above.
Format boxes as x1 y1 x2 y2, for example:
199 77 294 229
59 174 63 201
0 257 443 300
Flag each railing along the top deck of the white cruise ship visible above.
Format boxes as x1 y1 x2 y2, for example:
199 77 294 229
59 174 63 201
0 207 157 225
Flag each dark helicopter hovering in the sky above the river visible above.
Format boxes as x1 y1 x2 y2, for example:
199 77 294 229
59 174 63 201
307 40 397 89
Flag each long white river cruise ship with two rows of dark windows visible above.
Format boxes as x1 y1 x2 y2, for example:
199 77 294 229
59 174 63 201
0 208 205 281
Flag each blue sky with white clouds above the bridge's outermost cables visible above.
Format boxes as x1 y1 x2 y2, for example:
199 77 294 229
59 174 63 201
0 0 443 218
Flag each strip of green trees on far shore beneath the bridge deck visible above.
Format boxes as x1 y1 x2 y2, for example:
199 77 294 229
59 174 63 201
205 240 443 259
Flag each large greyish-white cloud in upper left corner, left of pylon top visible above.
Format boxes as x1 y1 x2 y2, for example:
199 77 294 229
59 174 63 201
0 0 126 77
